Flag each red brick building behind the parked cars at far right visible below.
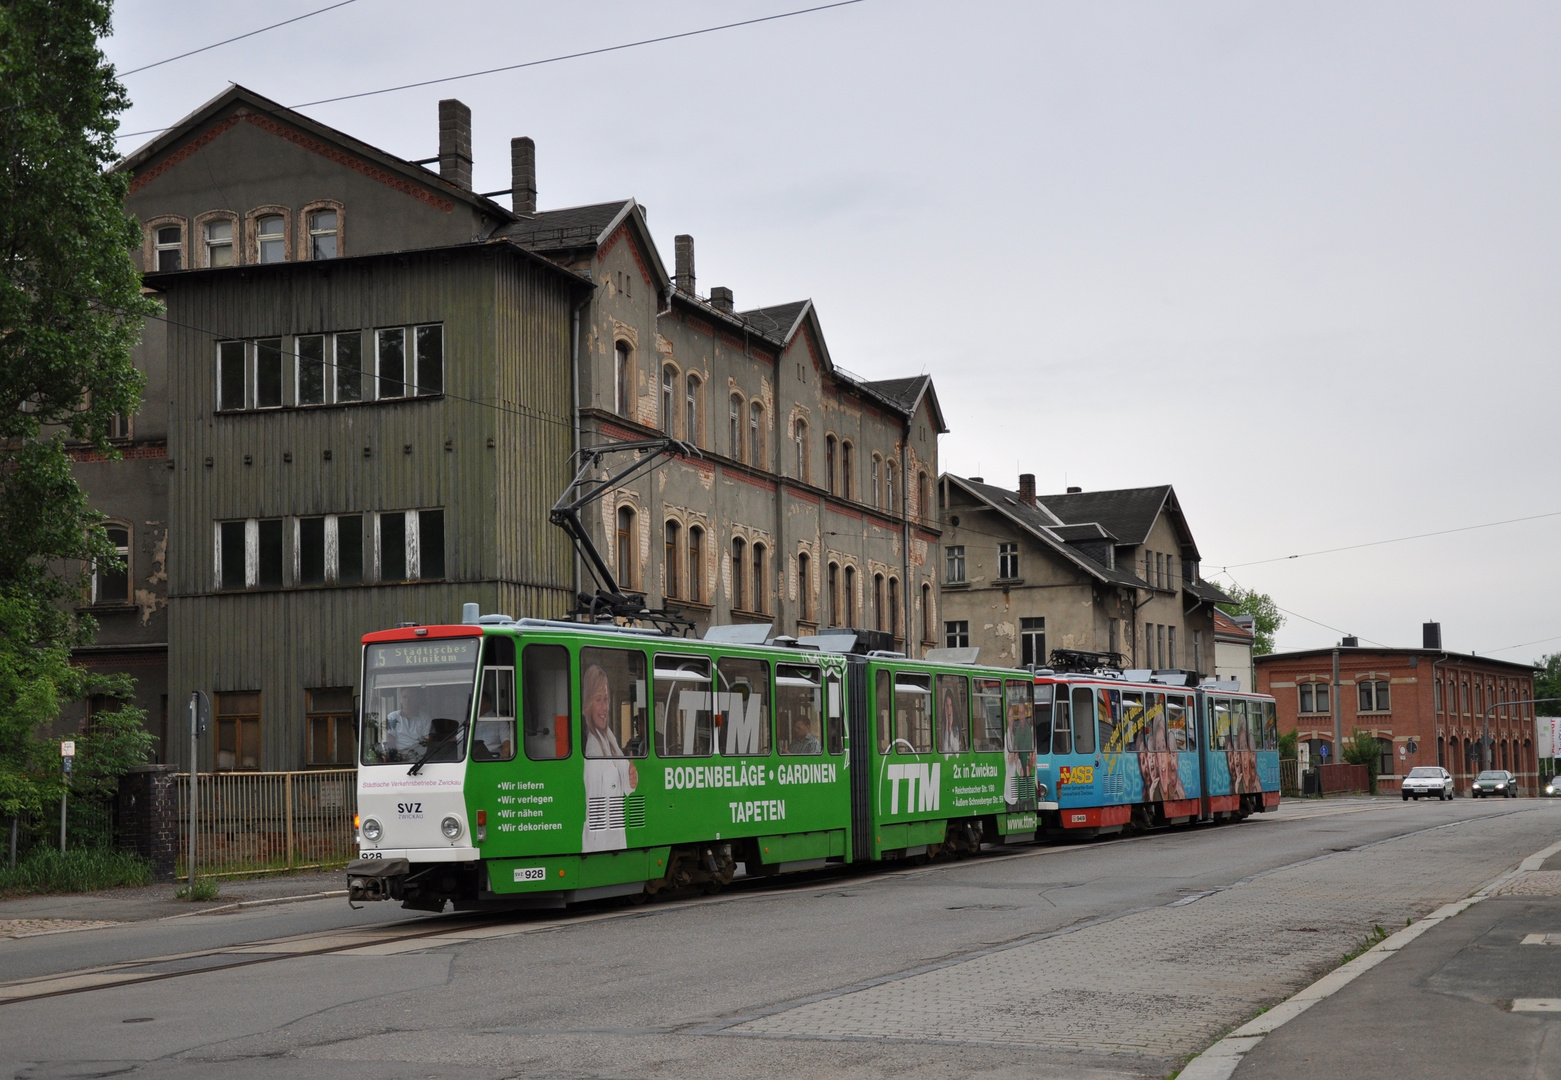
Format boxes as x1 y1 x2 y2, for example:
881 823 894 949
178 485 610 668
1257 624 1538 793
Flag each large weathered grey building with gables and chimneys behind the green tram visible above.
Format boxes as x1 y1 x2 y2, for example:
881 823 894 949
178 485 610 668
106 87 944 769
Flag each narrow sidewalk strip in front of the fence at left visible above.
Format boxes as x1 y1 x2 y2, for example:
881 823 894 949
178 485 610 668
0 871 347 938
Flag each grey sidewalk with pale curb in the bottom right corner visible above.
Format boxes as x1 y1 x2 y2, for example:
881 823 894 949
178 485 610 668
1233 854 1561 1080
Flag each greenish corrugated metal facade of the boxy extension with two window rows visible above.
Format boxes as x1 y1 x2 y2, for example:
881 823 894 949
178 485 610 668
162 245 579 769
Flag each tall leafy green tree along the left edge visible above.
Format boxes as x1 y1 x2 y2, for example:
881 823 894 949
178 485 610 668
0 0 158 813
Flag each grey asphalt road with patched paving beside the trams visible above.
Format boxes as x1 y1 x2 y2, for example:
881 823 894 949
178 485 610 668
0 799 1561 1080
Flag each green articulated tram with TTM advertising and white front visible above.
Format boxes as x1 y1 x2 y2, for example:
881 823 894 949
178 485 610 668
348 615 1055 910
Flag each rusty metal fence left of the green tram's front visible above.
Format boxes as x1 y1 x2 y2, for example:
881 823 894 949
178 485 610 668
175 769 357 874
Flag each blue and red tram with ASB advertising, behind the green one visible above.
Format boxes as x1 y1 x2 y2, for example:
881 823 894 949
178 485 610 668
1035 670 1278 835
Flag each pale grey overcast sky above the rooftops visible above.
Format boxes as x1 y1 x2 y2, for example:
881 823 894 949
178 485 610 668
106 0 1561 660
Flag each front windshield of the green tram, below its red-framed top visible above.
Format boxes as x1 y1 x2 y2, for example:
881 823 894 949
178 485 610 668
361 638 481 765
